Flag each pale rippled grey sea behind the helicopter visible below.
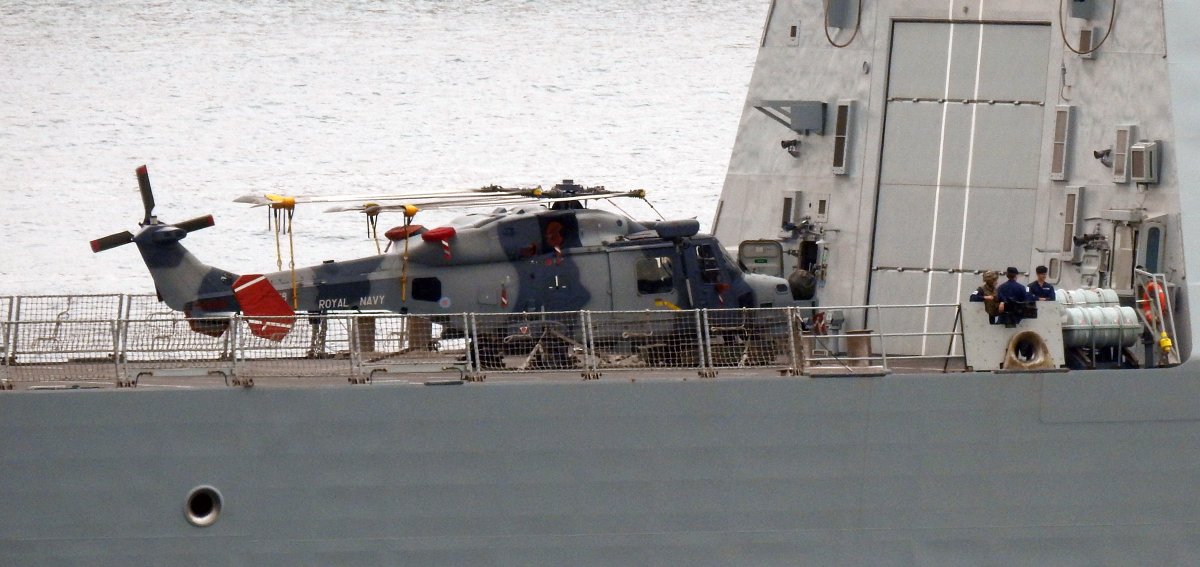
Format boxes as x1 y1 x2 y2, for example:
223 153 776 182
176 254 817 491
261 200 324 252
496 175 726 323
0 0 768 296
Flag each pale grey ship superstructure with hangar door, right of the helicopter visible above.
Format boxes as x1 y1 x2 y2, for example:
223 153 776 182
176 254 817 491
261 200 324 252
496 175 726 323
714 0 1190 358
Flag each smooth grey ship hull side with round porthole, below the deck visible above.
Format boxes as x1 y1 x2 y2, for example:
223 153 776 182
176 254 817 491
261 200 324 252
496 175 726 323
0 369 1200 565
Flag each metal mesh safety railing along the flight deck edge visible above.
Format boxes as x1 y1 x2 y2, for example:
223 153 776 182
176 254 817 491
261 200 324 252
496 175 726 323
0 294 962 386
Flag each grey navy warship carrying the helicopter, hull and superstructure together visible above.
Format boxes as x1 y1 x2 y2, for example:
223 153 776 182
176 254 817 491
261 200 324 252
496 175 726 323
0 0 1200 566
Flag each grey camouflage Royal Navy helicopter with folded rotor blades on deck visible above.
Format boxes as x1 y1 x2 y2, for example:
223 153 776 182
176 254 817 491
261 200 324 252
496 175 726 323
91 166 794 362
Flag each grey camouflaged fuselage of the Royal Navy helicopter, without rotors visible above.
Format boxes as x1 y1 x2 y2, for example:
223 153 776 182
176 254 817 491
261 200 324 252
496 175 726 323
134 207 792 324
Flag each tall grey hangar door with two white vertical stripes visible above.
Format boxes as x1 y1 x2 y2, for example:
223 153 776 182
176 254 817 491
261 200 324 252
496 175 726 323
870 22 1051 354
